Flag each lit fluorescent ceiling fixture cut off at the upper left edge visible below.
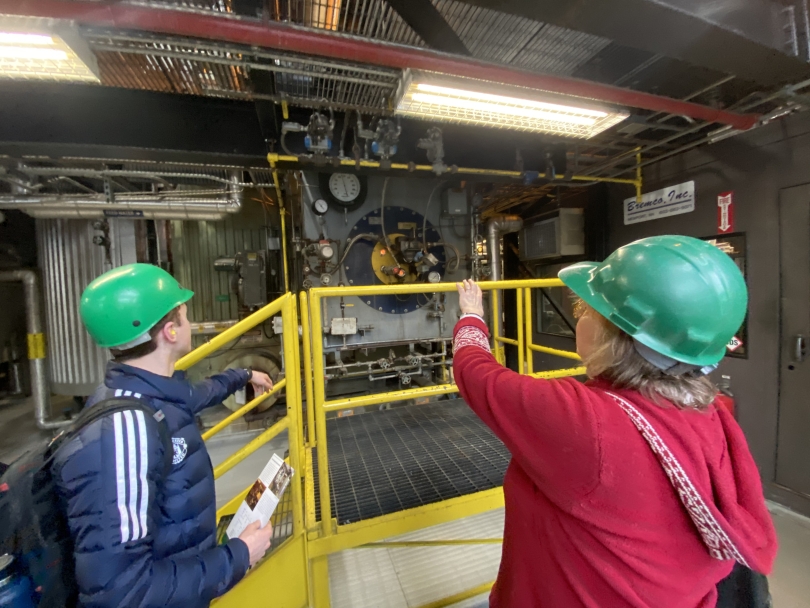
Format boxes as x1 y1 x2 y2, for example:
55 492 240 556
0 15 99 82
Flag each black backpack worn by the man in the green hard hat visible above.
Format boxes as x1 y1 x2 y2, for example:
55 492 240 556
0 398 173 608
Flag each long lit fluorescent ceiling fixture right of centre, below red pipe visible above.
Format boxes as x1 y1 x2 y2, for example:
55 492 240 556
396 70 630 139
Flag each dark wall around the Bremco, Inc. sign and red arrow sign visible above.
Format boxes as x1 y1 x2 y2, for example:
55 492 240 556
609 114 810 509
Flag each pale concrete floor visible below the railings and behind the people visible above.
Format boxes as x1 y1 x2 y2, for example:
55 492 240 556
0 400 810 608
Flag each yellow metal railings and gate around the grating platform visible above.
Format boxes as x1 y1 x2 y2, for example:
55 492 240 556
178 279 584 608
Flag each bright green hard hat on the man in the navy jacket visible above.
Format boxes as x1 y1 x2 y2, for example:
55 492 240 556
79 264 194 349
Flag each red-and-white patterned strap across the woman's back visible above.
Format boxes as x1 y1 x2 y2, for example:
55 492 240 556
605 391 748 566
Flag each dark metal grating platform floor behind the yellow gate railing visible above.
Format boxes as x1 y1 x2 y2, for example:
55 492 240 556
312 399 510 525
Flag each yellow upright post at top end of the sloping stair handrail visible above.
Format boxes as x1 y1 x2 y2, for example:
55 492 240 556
281 293 305 535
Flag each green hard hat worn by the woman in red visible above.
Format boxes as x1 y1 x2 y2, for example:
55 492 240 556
560 236 748 366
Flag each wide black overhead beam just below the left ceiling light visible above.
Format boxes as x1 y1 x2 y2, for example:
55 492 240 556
0 81 267 158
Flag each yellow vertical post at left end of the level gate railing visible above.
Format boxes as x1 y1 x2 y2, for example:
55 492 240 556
309 290 332 536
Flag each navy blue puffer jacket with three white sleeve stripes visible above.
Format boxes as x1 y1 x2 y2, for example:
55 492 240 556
53 363 249 608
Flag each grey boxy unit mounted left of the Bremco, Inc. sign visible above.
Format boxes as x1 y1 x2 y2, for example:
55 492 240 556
519 209 585 261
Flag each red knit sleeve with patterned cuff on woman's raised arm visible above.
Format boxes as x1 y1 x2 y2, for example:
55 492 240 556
453 317 600 499
